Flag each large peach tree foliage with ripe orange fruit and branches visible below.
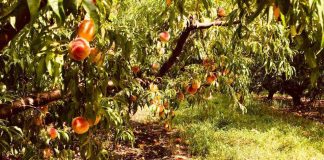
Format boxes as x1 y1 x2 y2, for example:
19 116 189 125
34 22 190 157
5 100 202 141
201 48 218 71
0 0 324 159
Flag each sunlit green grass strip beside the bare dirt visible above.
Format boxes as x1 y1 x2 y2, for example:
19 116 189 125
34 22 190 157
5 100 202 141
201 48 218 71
173 96 324 160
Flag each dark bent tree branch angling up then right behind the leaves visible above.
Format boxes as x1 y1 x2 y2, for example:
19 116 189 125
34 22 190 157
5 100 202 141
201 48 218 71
156 21 240 77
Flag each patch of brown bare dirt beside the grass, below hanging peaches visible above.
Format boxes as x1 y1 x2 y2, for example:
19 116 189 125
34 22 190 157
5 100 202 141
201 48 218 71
114 121 191 160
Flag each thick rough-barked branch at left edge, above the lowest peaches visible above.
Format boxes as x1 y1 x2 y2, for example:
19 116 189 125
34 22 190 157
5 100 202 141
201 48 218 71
0 90 62 118
